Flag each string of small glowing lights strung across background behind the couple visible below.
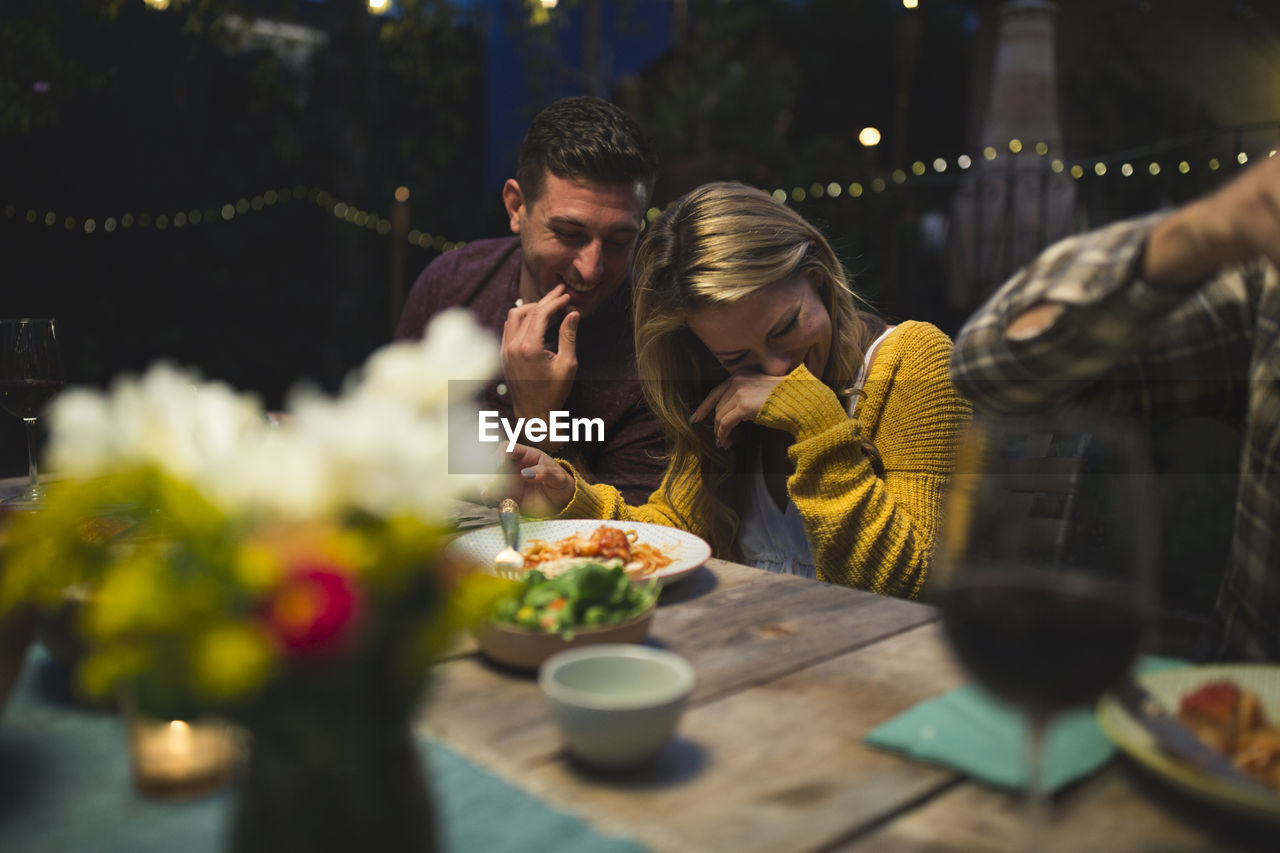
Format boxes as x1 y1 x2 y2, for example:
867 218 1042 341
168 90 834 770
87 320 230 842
3 140 1276 240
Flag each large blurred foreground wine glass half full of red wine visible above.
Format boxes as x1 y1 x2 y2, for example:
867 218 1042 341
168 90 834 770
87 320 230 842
937 414 1156 849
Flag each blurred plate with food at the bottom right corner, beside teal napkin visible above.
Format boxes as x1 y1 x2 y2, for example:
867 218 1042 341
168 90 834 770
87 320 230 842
1097 663 1280 821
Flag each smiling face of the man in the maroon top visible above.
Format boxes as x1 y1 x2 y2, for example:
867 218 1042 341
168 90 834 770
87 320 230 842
502 174 646 318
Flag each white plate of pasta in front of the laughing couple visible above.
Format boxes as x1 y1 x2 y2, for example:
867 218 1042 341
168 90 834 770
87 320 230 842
448 519 712 585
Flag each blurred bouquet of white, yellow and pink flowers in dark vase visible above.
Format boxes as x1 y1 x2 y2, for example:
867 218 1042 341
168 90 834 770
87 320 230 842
0 313 499 850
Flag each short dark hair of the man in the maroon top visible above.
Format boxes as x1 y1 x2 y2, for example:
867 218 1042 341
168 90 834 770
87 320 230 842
516 95 658 204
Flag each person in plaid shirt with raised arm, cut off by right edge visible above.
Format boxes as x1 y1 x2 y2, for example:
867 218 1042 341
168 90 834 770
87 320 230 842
951 158 1280 661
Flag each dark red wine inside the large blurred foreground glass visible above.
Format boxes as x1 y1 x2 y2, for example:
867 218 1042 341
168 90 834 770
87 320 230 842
942 570 1142 715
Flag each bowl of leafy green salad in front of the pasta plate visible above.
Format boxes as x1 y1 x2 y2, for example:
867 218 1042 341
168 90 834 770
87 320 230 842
472 562 660 670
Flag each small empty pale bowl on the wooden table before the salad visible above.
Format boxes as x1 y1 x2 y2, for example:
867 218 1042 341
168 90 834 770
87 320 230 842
538 644 696 770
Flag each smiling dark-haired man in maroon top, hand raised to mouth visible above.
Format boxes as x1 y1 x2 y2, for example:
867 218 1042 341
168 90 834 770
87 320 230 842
396 97 664 503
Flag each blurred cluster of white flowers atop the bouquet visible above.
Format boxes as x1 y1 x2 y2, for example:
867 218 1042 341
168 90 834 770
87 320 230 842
41 311 498 519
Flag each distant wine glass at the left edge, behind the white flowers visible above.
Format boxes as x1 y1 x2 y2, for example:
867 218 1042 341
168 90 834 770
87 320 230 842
0 319 67 507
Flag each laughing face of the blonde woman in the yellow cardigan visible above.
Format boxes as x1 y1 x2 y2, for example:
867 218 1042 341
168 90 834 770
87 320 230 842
689 274 831 379
